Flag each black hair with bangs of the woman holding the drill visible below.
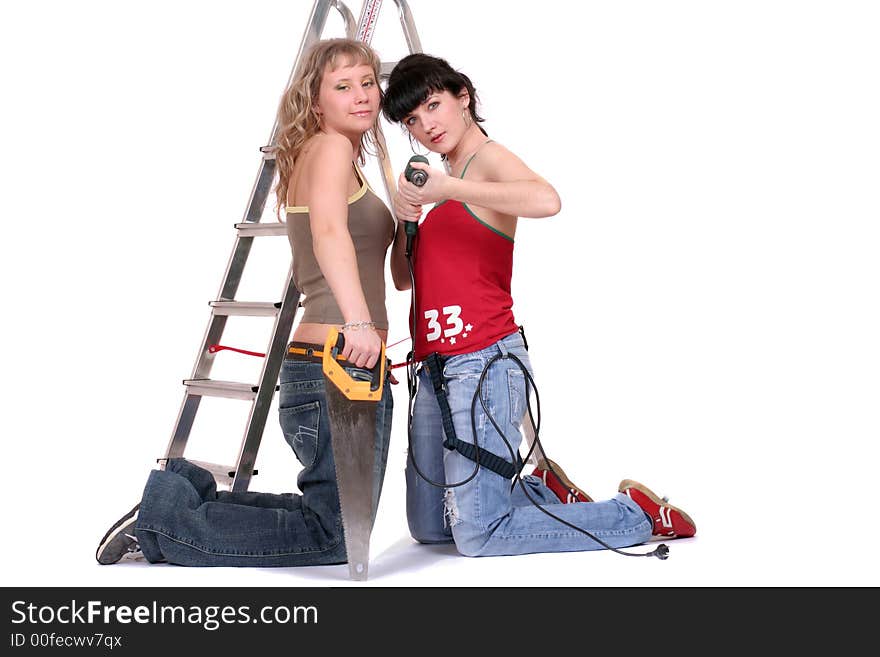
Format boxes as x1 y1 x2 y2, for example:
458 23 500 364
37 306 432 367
382 53 488 136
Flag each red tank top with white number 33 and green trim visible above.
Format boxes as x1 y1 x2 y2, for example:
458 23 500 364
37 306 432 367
410 201 517 360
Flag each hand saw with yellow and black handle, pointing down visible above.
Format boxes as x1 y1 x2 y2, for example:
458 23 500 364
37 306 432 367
322 328 385 580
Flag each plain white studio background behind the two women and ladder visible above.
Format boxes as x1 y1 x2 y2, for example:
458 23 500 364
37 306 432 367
0 0 880 586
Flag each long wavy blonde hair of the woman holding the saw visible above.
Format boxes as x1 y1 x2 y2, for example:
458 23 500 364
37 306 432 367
273 39 385 220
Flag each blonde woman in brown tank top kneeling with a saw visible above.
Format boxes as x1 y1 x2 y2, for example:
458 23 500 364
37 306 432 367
96 39 407 566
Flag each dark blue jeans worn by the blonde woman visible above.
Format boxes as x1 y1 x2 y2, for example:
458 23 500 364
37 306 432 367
135 360 394 567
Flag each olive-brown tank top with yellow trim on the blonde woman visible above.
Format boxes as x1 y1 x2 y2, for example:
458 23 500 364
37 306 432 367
286 167 394 330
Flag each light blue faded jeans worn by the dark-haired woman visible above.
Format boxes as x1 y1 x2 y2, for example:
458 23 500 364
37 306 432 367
406 333 652 557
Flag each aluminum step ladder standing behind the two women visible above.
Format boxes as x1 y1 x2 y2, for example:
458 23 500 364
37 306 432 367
158 0 422 491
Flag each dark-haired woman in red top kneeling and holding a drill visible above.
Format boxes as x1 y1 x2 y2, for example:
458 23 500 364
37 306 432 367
384 54 696 556
